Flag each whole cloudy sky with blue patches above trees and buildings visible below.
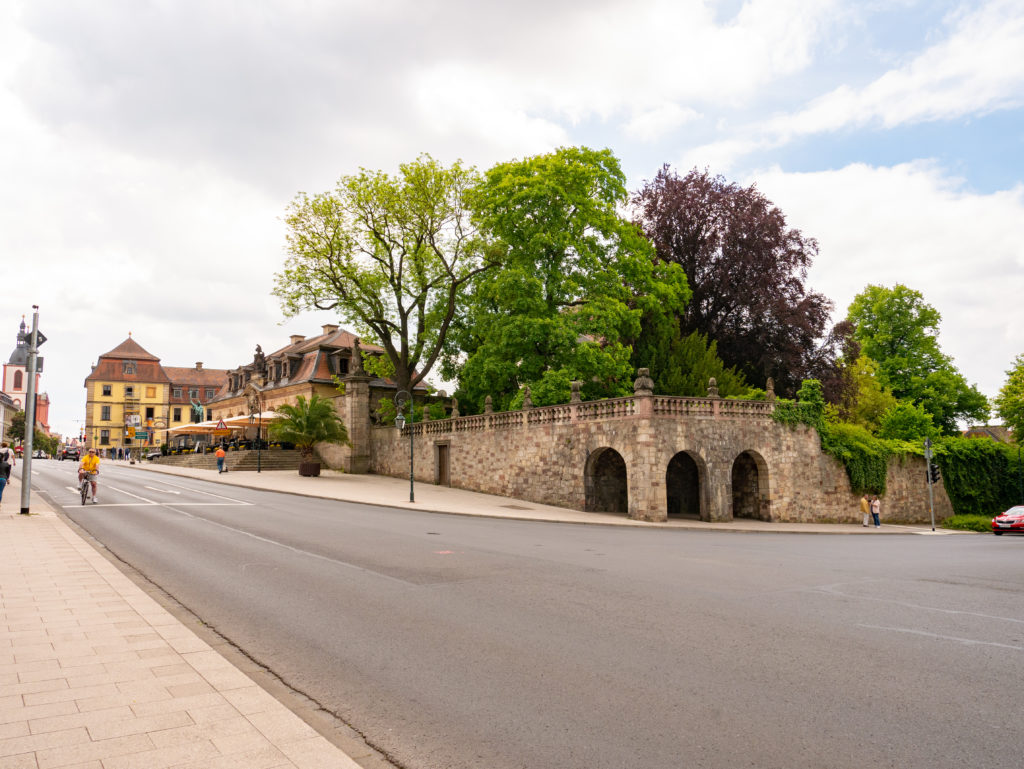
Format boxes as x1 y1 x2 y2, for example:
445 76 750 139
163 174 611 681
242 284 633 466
0 0 1024 442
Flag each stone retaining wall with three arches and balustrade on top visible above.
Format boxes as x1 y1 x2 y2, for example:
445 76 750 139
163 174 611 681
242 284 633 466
369 394 952 523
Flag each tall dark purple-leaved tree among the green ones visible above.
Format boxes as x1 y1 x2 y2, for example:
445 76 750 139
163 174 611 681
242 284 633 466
633 166 836 395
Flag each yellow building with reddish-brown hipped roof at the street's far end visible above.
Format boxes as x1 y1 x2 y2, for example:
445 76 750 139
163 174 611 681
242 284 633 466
84 334 227 450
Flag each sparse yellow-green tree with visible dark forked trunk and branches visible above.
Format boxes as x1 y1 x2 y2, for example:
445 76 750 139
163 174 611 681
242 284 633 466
273 155 495 392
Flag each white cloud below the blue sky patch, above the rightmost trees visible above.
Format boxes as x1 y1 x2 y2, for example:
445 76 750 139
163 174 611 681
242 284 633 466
749 163 1024 396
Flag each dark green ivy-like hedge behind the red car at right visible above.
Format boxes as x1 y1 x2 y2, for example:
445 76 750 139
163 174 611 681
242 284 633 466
933 438 1024 516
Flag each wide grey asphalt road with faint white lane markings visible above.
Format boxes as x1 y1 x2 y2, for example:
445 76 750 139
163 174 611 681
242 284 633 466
28 462 1024 769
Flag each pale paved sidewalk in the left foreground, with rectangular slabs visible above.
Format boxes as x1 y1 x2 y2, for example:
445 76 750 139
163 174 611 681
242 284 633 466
0 479 358 769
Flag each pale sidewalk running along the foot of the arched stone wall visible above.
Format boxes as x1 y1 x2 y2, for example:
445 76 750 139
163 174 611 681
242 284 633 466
128 459 950 537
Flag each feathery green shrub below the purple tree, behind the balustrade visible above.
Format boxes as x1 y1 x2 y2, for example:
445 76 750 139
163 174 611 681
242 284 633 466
632 327 750 397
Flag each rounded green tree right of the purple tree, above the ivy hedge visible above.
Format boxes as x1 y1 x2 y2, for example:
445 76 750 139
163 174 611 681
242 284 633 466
849 285 988 435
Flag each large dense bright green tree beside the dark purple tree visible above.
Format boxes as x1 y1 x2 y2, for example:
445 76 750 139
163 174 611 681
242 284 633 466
442 147 688 411
